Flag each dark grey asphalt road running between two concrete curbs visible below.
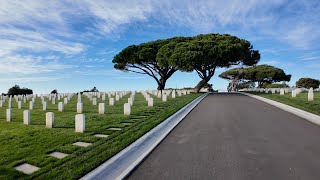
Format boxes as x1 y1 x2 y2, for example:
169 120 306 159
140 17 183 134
128 94 320 180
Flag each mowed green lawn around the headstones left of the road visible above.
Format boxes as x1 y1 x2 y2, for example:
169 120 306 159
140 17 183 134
0 93 201 179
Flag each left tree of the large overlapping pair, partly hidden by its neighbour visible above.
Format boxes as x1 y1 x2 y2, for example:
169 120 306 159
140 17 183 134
112 37 191 90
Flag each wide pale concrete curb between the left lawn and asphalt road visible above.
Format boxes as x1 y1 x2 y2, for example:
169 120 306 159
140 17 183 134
81 93 209 180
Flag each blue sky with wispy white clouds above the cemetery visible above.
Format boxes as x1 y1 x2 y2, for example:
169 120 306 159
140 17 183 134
0 0 320 93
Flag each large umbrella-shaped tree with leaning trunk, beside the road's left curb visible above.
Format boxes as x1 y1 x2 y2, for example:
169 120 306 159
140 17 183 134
169 34 260 92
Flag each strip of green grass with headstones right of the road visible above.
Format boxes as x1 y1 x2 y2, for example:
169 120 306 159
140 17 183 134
248 92 320 115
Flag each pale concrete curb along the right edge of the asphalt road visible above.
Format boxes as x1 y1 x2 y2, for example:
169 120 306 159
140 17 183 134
238 92 320 125
